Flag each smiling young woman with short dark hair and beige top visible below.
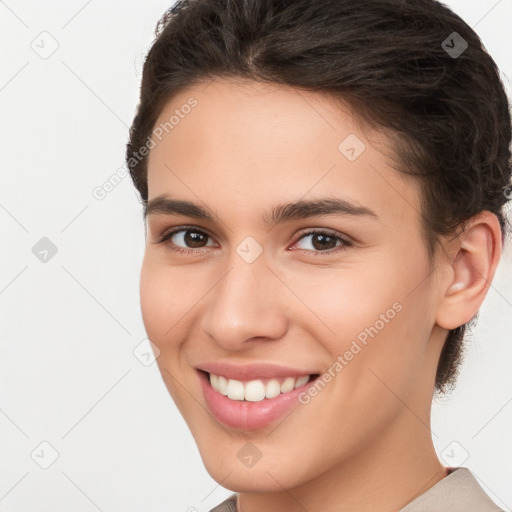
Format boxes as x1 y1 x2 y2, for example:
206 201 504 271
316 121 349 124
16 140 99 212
126 0 512 512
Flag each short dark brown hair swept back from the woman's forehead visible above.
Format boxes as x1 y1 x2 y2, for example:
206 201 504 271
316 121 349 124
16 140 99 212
126 0 512 393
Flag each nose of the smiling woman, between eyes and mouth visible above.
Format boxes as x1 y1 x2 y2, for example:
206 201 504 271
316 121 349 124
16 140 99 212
201 254 290 350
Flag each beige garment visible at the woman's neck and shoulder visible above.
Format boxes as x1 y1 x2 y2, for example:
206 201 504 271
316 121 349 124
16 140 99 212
210 467 504 512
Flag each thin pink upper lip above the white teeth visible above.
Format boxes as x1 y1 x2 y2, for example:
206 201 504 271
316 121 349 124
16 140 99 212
196 362 317 381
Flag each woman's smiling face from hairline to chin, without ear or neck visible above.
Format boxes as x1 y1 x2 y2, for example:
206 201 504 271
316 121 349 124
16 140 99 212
141 79 441 491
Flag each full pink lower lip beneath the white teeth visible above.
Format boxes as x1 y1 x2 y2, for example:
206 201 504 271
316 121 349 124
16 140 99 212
198 371 316 430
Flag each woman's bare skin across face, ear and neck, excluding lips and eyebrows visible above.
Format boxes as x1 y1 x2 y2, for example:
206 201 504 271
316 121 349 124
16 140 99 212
140 79 501 512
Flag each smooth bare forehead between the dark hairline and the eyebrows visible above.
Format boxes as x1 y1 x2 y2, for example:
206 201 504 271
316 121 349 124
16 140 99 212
144 79 419 228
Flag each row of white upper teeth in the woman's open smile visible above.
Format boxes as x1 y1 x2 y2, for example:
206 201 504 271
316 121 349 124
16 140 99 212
210 373 309 402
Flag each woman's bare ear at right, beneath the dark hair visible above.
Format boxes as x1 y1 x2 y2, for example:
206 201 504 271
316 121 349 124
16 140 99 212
436 211 502 330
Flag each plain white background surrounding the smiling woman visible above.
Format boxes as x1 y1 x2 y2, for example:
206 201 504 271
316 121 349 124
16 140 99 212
0 0 512 512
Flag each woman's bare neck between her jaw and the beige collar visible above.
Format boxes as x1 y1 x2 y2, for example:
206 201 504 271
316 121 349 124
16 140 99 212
239 410 446 512
